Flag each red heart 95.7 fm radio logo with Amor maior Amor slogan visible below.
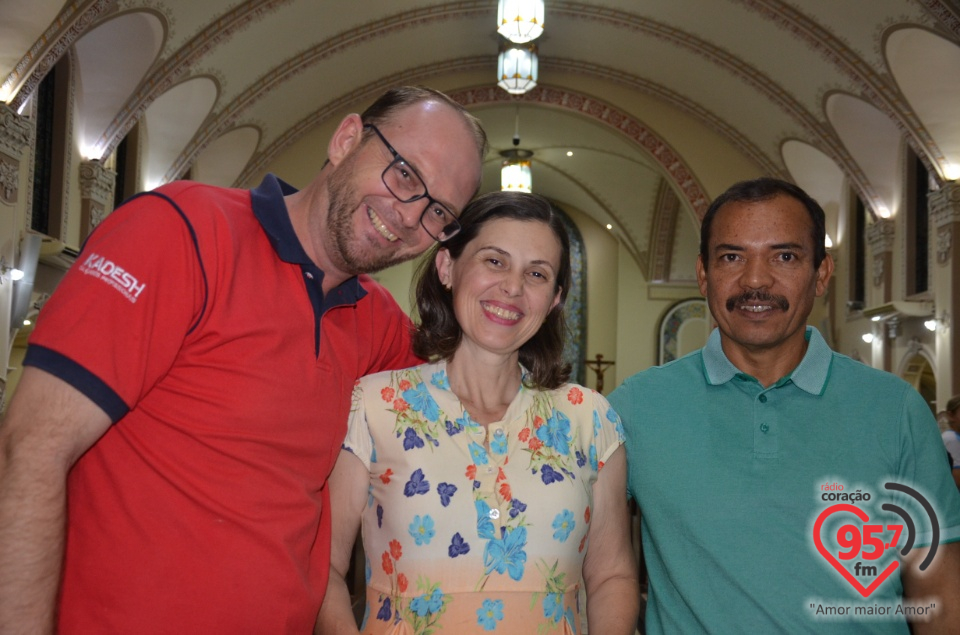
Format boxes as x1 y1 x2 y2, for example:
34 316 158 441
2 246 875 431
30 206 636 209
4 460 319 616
809 482 940 617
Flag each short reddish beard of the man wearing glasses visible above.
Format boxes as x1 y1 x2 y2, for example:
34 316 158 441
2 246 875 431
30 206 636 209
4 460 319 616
326 157 408 275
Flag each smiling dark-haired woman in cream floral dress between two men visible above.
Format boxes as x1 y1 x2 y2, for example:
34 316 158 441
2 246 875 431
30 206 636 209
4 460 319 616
317 192 639 635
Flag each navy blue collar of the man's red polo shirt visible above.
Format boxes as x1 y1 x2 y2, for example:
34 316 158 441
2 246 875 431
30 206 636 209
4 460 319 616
250 174 367 302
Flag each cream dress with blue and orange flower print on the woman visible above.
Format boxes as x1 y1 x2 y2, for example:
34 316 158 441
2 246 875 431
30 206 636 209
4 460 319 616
344 361 623 635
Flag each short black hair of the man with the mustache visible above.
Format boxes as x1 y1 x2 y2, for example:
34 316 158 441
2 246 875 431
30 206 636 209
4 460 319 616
700 177 827 269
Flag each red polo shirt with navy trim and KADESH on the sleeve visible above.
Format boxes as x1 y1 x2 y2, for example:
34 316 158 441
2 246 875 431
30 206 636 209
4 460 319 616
25 176 417 634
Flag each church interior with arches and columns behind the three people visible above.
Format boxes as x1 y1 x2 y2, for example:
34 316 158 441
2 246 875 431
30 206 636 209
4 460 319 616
0 0 960 422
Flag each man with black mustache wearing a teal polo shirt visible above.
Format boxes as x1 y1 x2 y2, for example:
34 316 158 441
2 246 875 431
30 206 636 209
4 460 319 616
610 178 960 633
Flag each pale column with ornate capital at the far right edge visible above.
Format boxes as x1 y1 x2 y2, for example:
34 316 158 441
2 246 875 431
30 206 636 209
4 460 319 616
928 181 960 408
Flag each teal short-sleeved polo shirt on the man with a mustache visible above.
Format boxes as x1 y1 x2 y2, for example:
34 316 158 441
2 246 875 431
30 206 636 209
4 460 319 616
610 327 960 634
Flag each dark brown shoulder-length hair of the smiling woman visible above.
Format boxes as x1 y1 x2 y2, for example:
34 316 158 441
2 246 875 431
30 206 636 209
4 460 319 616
413 192 572 390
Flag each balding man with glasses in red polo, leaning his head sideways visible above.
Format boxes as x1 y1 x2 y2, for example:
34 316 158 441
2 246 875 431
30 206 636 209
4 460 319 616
0 88 486 635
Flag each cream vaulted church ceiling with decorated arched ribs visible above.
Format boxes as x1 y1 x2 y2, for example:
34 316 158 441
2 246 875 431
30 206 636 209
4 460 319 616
0 0 960 282
